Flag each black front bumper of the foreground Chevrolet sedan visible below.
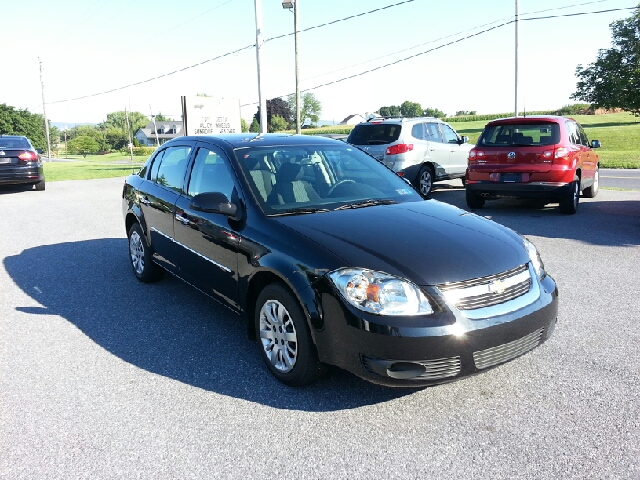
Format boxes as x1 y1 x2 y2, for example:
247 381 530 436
315 268 558 387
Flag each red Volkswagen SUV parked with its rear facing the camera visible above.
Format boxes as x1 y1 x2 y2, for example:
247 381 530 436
466 116 600 214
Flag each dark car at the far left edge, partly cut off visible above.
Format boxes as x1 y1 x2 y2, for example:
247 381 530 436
0 135 45 190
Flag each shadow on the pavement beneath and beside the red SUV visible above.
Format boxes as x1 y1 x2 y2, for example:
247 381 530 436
431 188 640 246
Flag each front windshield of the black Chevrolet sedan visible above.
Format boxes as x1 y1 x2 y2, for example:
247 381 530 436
235 141 422 215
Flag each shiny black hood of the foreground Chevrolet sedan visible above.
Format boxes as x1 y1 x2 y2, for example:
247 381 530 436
277 200 529 285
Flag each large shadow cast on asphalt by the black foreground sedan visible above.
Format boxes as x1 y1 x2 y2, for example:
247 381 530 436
4 238 417 412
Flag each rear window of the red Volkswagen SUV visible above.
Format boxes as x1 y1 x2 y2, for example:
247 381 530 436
478 123 560 147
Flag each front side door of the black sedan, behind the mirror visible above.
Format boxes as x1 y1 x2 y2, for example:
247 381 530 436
174 142 240 310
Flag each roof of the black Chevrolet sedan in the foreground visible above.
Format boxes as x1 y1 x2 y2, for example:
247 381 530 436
163 133 344 148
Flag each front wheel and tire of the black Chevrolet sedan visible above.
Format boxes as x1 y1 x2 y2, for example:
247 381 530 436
254 283 324 387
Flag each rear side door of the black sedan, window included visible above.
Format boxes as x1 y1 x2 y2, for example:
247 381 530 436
138 143 192 273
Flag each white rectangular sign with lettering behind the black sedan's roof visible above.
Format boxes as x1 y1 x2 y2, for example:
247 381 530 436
182 96 242 135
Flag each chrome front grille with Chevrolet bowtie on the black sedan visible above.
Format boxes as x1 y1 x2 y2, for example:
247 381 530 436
438 264 531 310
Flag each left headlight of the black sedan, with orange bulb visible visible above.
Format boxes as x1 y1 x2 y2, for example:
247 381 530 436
328 268 433 315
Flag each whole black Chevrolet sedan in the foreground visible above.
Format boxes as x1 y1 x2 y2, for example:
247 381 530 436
122 134 558 386
